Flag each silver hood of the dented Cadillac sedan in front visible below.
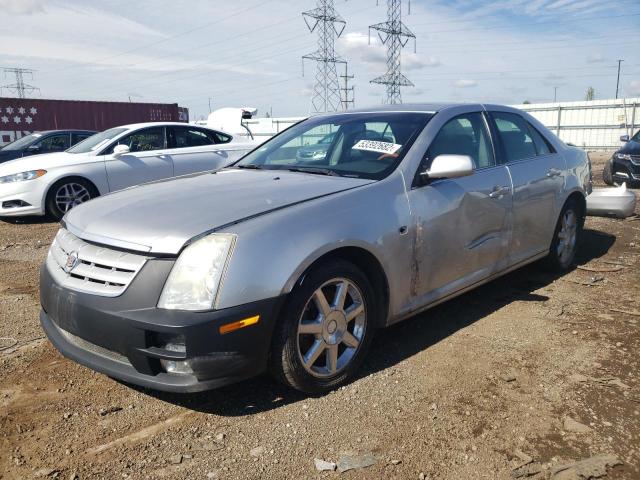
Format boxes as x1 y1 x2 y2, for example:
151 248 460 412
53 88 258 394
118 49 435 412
64 169 373 254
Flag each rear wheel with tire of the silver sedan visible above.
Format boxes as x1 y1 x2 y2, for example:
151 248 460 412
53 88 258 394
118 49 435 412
546 199 584 272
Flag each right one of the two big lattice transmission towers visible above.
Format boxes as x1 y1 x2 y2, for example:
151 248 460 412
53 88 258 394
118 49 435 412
369 0 416 104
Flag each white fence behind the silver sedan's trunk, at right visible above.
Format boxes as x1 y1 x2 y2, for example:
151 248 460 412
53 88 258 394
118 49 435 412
514 98 640 150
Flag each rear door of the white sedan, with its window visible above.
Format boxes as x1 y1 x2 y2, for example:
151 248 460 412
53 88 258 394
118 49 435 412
166 126 235 176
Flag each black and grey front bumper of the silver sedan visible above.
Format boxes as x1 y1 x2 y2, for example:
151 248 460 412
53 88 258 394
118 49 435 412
40 260 282 392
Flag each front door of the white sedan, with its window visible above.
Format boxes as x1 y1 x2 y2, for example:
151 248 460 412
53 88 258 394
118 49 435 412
103 127 173 192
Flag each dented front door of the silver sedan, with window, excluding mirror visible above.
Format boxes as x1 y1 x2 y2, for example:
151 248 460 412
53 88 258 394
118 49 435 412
409 112 512 306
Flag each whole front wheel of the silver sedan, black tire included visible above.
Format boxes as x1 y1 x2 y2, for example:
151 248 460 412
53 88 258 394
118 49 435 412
269 259 380 394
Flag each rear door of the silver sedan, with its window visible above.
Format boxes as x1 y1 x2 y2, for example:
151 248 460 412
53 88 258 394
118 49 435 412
491 111 565 264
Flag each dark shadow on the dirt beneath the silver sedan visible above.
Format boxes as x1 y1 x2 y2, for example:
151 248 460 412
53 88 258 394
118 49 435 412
124 230 616 416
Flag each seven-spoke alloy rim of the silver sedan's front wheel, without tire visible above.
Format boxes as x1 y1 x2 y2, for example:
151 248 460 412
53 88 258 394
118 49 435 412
297 278 367 377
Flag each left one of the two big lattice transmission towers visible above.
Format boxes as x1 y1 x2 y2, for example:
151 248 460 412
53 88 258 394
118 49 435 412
302 0 347 113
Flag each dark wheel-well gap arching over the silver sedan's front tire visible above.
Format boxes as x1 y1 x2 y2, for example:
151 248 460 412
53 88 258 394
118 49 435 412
285 245 390 327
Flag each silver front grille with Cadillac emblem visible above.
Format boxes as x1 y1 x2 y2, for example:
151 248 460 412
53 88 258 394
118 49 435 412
47 228 148 297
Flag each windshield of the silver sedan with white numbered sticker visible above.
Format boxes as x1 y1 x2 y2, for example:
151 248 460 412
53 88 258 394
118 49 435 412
233 112 433 180
